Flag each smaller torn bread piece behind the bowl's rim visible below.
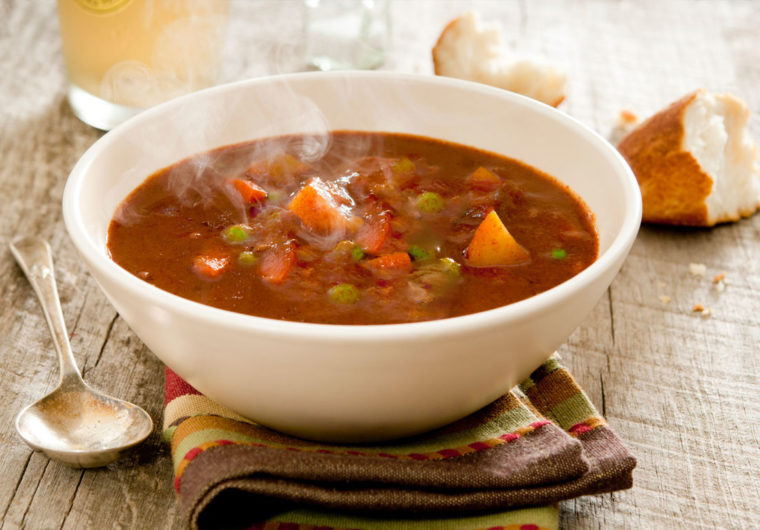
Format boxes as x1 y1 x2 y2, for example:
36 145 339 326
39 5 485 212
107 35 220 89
433 11 567 107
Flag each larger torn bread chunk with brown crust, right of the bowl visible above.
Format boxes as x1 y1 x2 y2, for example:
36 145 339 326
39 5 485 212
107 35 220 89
618 90 760 226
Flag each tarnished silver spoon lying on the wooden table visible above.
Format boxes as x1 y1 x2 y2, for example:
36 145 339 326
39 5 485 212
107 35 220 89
10 237 153 467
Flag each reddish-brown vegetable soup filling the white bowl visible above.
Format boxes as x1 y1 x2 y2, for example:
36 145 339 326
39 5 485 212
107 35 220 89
108 131 598 324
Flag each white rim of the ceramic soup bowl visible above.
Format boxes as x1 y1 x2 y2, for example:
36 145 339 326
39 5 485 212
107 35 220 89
62 71 642 342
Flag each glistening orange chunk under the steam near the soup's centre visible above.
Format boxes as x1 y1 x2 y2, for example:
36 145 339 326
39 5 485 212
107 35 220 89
288 177 358 232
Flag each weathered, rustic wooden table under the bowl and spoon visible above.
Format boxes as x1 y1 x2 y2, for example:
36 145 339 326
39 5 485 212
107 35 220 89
0 0 760 529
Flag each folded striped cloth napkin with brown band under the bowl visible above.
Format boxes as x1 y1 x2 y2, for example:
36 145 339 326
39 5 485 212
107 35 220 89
164 356 636 530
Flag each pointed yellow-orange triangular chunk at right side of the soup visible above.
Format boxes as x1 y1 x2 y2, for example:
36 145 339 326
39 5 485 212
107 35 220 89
467 210 530 267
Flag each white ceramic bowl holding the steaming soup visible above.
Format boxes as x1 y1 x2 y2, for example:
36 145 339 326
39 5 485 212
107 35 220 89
63 72 641 441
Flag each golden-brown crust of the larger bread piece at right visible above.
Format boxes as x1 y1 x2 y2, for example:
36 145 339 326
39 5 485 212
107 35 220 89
618 91 716 226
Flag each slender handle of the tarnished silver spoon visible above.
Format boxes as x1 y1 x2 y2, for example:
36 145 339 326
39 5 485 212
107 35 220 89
10 237 82 382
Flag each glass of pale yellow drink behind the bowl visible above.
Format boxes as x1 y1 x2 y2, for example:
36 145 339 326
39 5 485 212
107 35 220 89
58 0 229 109
